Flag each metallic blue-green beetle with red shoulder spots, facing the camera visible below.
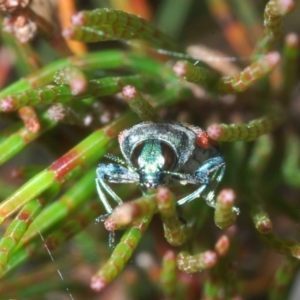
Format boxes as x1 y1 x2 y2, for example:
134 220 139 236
96 122 225 214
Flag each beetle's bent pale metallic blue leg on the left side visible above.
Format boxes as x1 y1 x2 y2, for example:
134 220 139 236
96 164 139 214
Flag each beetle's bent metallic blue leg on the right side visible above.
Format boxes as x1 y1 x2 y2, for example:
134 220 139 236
177 156 225 207
